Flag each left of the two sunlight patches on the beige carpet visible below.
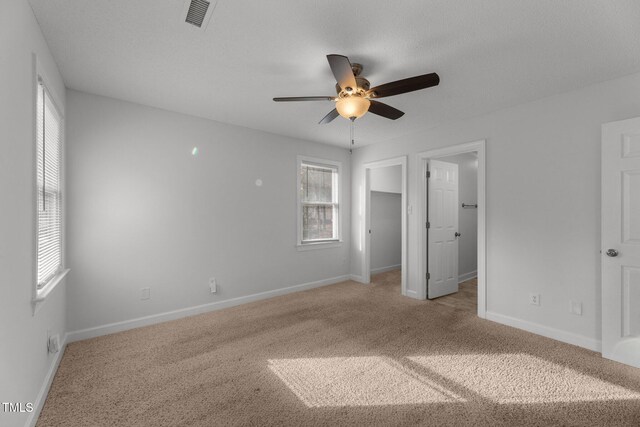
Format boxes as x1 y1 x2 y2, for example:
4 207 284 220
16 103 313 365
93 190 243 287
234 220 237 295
269 356 464 407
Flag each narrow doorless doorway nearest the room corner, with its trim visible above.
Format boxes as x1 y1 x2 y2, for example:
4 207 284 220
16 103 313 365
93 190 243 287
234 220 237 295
364 156 407 295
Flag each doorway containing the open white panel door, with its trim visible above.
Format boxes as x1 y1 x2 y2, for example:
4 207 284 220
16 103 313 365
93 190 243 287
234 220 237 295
418 140 487 318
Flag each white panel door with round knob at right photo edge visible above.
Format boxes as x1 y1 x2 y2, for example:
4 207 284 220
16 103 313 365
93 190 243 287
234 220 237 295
601 118 640 367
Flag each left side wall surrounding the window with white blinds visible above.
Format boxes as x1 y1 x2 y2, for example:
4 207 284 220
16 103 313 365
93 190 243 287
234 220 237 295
0 0 65 426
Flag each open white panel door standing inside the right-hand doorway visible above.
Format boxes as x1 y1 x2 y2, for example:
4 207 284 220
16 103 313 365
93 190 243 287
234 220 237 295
427 160 458 299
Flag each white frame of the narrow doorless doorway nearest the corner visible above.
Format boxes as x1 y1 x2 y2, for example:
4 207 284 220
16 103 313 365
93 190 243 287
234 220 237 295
361 156 408 296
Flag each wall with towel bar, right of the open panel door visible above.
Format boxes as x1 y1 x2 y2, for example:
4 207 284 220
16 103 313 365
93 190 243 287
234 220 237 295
438 153 478 280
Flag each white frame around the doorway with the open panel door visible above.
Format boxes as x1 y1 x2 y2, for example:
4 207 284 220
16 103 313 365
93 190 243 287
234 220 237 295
418 139 487 319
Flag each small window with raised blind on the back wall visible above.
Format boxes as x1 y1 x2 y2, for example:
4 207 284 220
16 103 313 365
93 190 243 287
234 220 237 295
298 157 341 245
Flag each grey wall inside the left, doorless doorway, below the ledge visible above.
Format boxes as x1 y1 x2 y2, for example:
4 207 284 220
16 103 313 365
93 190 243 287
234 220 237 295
370 191 402 274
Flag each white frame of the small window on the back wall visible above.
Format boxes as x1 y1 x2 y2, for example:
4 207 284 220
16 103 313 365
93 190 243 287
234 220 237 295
296 156 344 251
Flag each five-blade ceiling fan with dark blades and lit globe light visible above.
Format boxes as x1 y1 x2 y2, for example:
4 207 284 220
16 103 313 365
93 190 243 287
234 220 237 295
273 55 440 124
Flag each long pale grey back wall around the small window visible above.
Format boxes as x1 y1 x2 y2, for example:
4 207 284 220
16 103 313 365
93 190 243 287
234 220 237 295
67 91 351 331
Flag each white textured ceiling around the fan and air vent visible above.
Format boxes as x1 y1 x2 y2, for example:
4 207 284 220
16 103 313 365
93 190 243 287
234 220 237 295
30 0 640 147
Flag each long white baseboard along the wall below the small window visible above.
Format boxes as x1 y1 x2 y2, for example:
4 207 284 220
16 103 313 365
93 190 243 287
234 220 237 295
67 274 350 343
